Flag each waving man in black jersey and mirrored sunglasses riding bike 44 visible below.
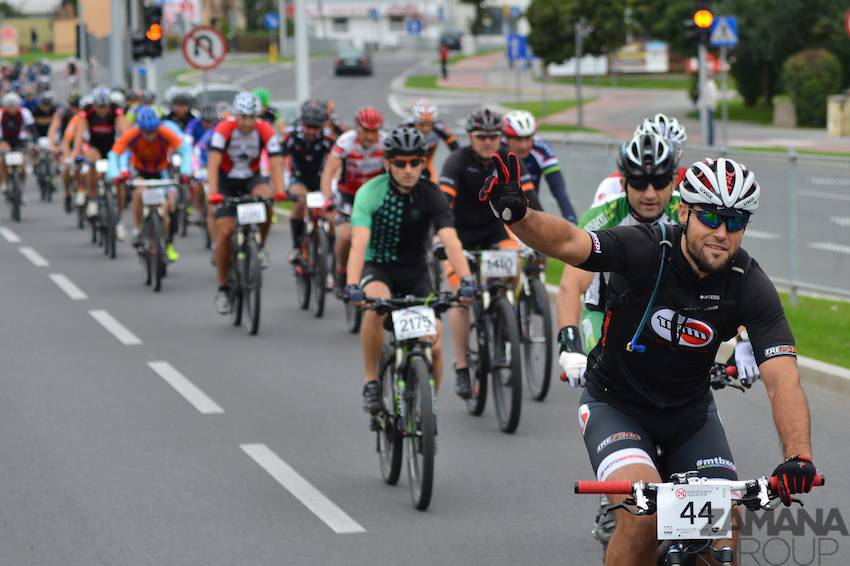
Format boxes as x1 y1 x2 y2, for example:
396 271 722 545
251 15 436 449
481 153 817 565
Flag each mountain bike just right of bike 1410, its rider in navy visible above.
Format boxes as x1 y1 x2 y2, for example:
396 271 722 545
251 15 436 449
516 247 555 401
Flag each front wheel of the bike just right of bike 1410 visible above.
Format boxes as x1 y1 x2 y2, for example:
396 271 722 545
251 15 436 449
519 279 553 401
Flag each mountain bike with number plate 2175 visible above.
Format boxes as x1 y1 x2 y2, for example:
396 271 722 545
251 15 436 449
362 293 457 511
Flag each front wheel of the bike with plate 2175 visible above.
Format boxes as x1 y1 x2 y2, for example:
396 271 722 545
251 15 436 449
405 356 436 511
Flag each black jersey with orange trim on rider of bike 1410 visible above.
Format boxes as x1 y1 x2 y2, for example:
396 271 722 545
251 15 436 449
440 146 540 234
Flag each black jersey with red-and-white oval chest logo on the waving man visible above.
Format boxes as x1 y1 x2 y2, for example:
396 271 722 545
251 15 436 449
578 225 796 408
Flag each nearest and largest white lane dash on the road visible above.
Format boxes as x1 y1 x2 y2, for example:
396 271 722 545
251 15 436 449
239 444 366 534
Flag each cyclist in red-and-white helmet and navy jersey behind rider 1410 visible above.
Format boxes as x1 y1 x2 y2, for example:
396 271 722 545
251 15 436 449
502 110 576 222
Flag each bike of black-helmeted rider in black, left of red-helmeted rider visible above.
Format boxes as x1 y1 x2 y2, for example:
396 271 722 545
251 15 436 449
290 192 332 318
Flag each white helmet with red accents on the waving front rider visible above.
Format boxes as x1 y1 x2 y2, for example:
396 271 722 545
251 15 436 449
679 158 761 212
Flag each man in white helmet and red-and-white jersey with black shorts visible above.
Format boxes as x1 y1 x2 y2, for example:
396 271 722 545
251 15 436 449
207 92 283 315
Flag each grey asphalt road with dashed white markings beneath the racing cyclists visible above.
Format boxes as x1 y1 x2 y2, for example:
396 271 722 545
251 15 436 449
0 180 850 566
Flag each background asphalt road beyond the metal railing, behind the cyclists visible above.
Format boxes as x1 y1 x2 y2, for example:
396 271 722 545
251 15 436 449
195 50 850 295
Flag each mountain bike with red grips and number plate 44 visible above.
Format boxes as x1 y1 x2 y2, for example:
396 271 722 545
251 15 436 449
575 471 825 566
